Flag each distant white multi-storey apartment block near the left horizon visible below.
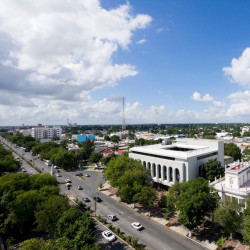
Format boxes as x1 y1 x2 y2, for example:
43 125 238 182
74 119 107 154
31 126 62 139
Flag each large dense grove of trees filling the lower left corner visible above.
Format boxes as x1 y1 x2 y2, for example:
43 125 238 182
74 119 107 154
0 174 95 249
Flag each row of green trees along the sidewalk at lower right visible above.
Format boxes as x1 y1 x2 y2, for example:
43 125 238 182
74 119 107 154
159 177 250 245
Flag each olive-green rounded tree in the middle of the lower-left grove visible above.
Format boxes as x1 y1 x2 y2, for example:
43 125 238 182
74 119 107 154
35 195 69 233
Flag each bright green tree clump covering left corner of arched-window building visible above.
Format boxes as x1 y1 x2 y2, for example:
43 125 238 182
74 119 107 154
104 156 156 206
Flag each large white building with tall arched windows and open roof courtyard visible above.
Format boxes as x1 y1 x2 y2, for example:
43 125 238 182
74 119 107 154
129 138 224 186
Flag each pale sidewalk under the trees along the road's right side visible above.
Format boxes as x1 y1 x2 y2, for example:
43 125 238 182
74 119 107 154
100 182 249 250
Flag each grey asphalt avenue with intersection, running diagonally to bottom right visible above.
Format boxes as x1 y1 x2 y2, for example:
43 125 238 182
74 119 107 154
0 139 205 250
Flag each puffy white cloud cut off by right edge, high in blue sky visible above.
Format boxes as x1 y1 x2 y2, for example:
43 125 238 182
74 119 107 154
223 48 250 87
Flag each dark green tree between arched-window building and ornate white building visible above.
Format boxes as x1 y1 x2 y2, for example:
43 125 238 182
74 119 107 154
204 159 225 182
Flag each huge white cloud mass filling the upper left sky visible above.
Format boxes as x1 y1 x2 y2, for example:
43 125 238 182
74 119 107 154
0 0 152 100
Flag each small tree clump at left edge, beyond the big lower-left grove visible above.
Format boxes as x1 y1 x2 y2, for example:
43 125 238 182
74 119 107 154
0 144 19 176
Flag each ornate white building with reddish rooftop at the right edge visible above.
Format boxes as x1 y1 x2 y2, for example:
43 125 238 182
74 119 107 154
210 162 250 207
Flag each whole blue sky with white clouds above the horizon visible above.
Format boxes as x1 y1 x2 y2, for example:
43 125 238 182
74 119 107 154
0 0 250 126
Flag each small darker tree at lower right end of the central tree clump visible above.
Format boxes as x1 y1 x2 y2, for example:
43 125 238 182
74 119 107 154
133 186 156 206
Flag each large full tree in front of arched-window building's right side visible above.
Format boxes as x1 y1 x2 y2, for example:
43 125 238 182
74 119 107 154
176 177 219 228
